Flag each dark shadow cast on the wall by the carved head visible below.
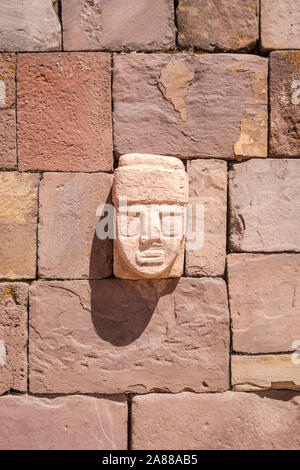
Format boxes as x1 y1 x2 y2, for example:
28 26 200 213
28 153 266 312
89 194 178 347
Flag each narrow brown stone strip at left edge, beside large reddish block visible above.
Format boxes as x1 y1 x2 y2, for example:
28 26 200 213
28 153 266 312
0 54 17 169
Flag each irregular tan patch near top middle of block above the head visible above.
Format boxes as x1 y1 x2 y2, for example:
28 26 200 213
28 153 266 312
158 61 195 122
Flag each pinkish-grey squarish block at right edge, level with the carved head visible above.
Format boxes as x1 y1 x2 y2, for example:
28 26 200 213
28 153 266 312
229 159 300 252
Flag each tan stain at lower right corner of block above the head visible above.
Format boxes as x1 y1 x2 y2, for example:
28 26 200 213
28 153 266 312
234 110 268 157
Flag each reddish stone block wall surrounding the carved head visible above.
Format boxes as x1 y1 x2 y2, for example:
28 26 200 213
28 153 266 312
0 0 300 449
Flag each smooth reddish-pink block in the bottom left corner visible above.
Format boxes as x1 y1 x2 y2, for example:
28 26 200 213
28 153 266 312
0 395 127 450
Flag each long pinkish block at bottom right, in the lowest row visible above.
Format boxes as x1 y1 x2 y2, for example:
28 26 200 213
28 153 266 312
132 392 300 450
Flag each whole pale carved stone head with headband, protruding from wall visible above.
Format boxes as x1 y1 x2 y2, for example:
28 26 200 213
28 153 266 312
113 154 188 279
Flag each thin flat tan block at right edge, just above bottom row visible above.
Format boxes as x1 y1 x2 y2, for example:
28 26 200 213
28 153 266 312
231 354 300 390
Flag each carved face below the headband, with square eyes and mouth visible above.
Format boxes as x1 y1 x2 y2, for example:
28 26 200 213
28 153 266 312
116 203 184 277
